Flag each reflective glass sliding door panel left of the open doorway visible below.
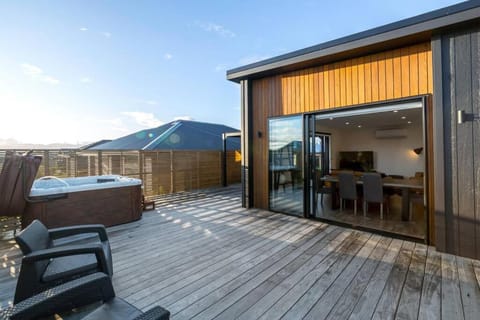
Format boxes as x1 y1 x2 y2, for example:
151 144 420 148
269 116 303 215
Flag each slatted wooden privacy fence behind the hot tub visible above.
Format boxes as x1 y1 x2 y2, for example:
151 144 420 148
0 149 241 196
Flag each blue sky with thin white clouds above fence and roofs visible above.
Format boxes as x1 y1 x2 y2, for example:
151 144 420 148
0 0 459 147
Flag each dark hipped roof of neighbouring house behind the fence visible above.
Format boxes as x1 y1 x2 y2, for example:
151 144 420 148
89 120 240 150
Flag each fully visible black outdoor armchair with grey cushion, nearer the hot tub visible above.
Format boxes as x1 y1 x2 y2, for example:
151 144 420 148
14 220 113 304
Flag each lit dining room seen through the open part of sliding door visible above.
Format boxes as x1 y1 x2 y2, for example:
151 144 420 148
310 101 428 241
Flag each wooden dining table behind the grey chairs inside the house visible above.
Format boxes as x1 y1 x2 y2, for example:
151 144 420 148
321 175 424 221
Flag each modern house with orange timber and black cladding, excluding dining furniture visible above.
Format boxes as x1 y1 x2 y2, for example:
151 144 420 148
227 1 480 259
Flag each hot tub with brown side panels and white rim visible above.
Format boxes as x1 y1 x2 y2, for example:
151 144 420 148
22 175 142 228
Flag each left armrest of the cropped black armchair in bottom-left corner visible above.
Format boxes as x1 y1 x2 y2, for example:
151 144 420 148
0 272 115 320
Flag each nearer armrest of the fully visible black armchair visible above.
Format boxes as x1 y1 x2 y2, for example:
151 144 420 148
22 243 109 274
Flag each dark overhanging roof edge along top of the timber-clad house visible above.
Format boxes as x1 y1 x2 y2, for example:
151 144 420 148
227 0 480 82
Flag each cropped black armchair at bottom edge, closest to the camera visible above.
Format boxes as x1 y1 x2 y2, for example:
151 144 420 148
0 272 170 320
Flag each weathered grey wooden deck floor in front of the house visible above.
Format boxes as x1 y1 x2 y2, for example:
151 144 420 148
0 186 480 319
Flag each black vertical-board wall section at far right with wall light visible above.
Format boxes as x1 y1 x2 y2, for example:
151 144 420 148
434 27 480 259
